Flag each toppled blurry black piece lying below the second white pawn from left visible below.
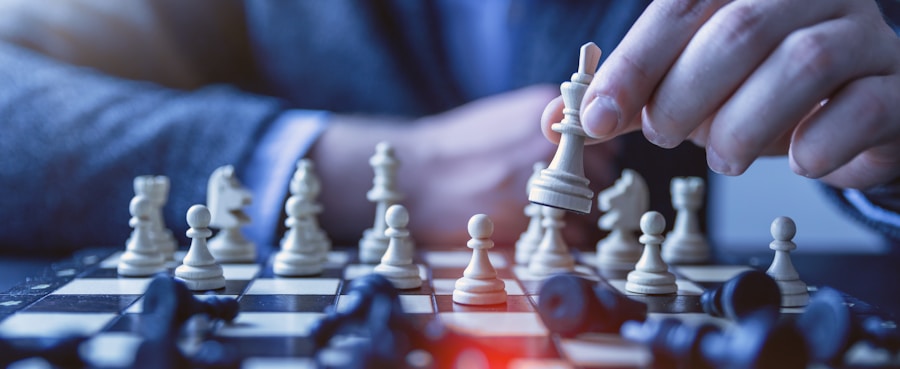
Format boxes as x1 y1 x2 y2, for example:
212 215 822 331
141 274 240 339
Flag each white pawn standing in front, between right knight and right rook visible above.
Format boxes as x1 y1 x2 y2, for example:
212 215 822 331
625 211 678 295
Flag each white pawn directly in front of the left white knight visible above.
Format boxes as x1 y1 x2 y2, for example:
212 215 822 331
175 205 225 291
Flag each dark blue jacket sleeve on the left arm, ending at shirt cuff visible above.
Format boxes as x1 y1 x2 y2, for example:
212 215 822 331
0 41 280 251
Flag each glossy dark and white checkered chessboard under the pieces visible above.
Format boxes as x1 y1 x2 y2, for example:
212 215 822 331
0 243 900 368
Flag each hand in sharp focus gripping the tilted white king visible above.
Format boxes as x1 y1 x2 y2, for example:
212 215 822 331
542 0 900 188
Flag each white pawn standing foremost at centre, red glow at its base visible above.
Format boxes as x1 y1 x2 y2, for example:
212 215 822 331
453 214 506 305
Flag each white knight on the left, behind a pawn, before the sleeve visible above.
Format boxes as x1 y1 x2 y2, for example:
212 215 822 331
206 165 256 263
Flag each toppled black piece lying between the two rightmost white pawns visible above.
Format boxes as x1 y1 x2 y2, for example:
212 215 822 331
700 270 781 321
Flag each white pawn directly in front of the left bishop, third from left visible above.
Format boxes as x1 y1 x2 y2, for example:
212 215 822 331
272 196 324 277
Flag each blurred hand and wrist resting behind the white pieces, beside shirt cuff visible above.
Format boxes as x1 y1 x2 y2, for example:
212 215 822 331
311 86 615 246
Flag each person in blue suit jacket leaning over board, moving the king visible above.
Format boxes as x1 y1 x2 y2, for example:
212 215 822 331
0 0 900 252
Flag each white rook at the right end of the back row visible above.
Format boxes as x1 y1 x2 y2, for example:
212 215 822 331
662 177 710 264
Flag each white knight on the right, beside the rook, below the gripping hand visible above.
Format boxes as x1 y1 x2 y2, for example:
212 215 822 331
597 169 650 275
